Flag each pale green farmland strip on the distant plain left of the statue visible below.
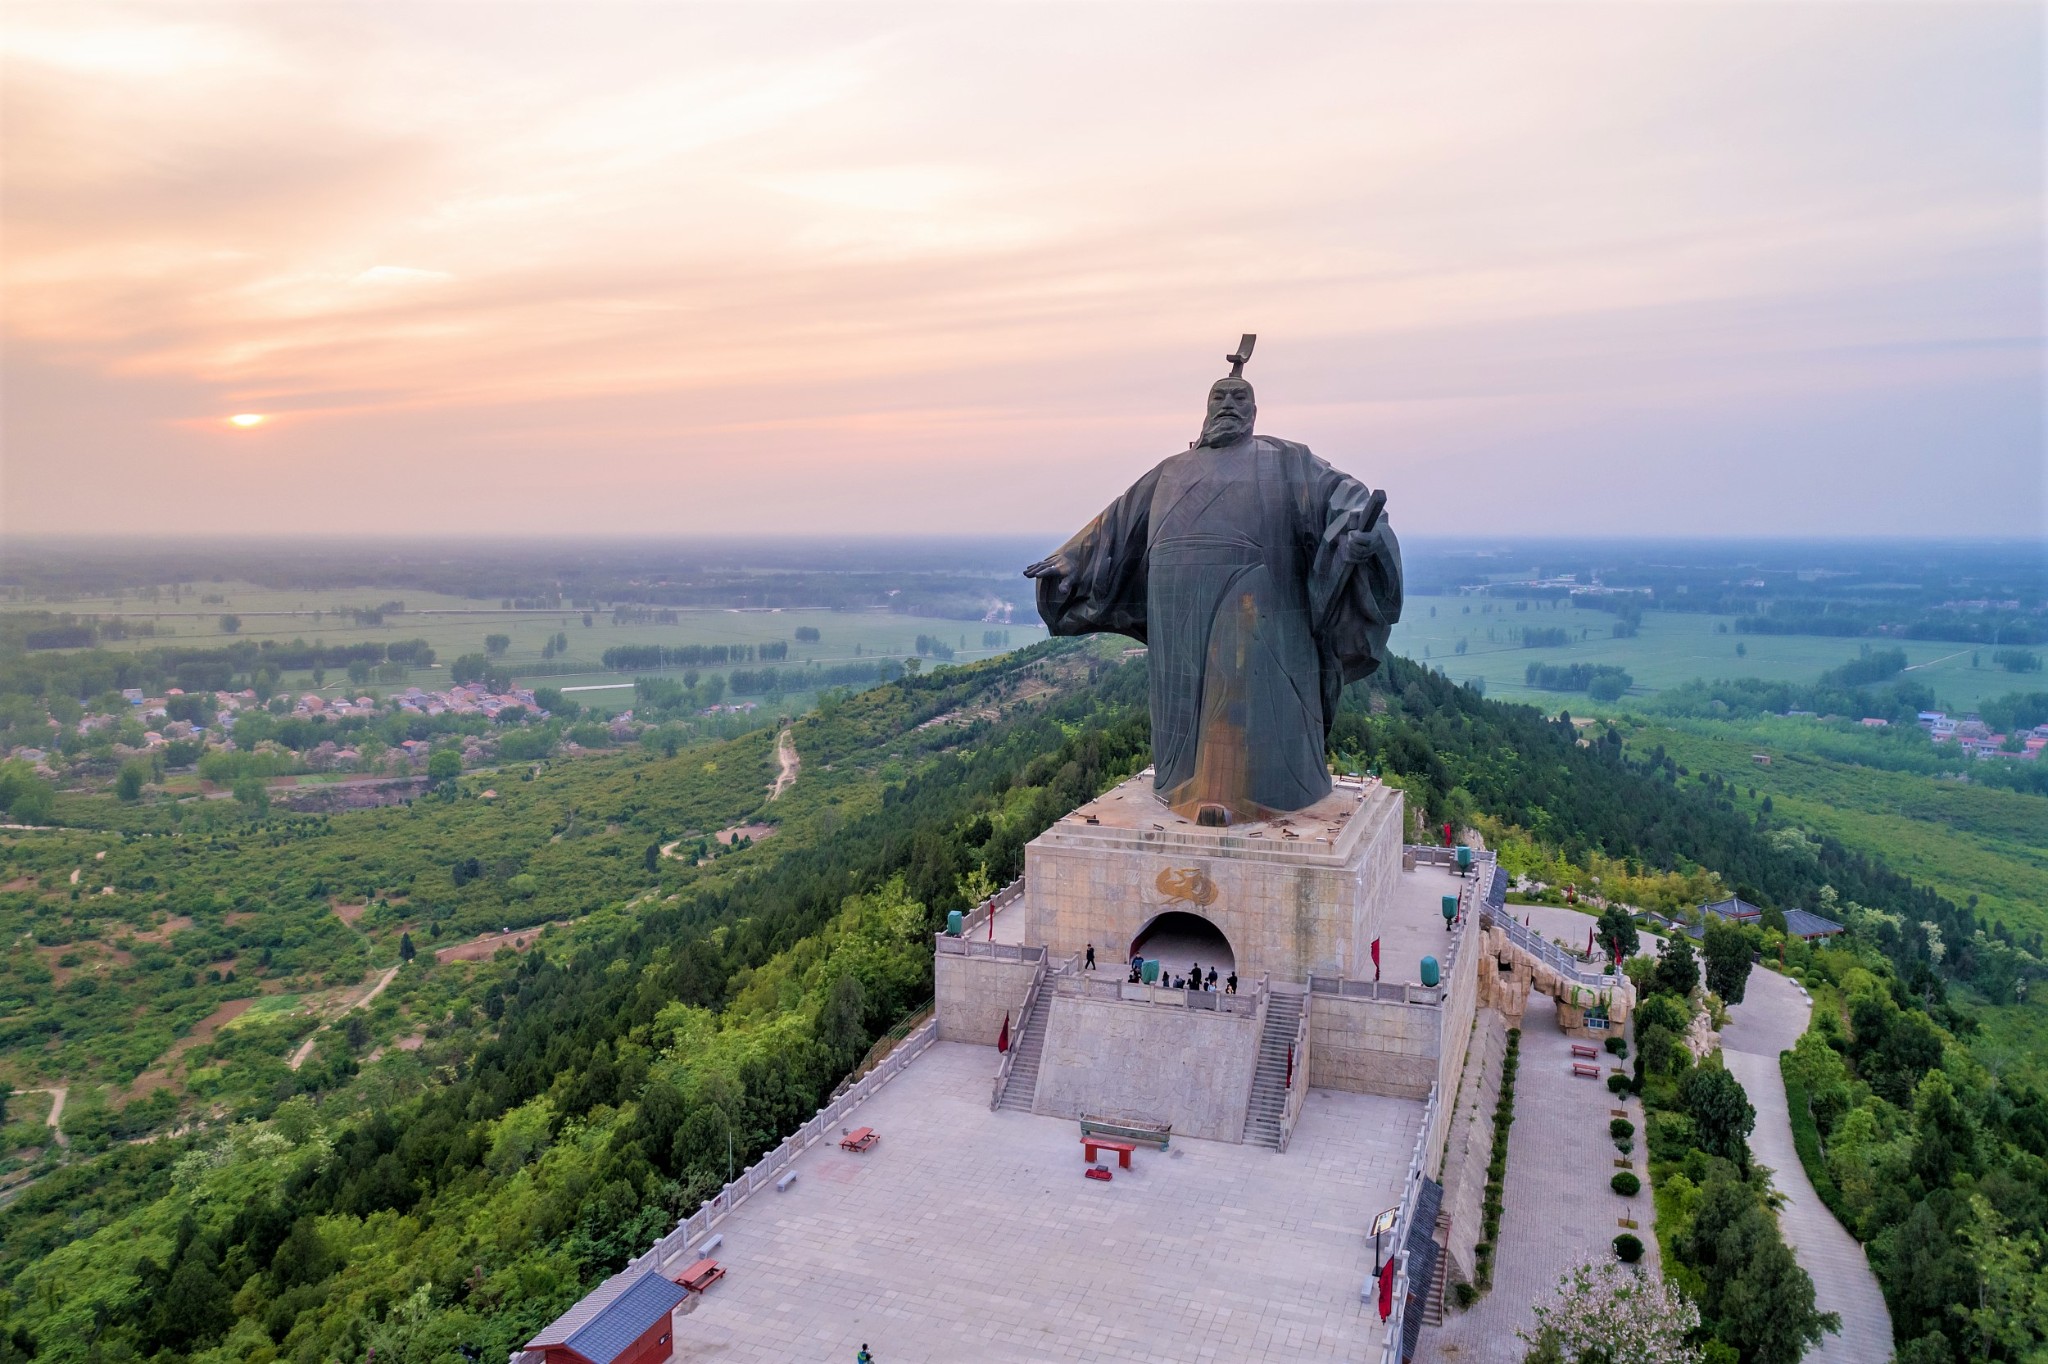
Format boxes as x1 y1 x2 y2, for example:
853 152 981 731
0 584 1047 711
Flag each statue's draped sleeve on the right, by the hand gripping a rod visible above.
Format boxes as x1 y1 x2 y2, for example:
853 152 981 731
1305 457 1401 684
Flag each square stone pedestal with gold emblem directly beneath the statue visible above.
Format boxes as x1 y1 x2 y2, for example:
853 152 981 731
1024 772 1403 981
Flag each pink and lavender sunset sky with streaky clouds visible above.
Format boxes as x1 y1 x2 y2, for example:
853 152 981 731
0 0 2048 535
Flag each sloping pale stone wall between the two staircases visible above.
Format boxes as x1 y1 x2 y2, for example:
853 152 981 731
1032 993 1264 1141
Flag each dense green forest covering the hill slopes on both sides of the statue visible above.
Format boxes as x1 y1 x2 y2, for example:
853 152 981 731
0 643 2048 1364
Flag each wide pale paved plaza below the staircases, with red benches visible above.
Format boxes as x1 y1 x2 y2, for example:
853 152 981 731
676 1042 1421 1364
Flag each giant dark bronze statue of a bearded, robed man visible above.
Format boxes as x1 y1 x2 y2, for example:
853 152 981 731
1024 336 1401 825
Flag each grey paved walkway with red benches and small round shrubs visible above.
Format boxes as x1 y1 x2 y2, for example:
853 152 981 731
1415 987 1657 1364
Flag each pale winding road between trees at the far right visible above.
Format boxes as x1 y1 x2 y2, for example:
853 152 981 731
1720 967 1892 1364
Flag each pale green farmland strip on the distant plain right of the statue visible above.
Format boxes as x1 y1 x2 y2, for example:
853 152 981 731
1393 596 2025 715
